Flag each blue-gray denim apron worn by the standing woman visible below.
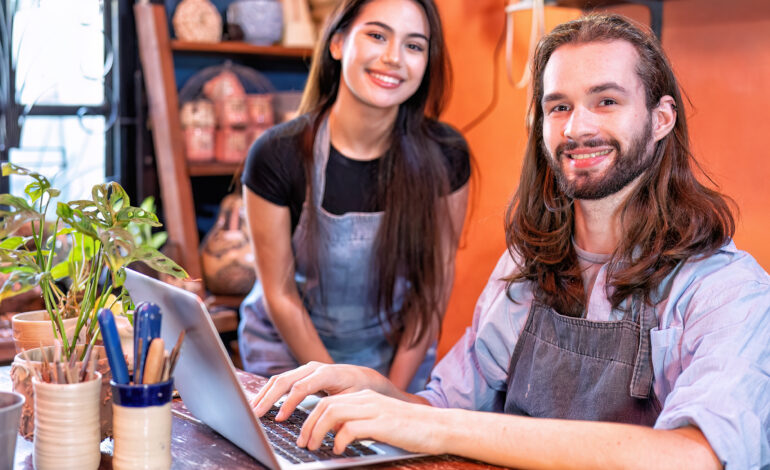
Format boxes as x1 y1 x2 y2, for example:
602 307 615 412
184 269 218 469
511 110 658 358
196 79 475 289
238 119 436 391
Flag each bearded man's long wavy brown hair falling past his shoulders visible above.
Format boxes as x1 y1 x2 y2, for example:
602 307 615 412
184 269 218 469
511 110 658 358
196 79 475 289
505 14 735 316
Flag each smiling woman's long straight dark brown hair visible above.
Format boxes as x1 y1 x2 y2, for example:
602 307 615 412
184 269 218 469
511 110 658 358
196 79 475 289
300 0 464 345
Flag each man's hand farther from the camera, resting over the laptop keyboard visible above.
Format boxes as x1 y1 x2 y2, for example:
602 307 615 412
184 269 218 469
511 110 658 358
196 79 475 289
252 362 399 421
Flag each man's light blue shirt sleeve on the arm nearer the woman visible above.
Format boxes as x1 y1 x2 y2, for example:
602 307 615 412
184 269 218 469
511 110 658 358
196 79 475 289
419 252 532 411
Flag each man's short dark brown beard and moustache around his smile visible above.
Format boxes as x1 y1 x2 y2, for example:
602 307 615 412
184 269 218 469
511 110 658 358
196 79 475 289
543 117 654 199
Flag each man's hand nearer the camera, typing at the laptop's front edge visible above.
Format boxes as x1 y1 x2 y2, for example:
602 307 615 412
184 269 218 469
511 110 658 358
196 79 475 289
297 390 447 454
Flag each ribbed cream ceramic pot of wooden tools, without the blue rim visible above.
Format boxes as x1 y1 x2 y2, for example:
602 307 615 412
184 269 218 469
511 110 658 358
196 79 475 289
32 372 102 470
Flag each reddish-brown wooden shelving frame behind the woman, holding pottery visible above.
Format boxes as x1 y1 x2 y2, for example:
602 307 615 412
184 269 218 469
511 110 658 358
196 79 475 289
134 2 312 331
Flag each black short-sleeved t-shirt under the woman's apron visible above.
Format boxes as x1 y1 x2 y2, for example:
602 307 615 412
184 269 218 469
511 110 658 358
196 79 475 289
241 116 471 233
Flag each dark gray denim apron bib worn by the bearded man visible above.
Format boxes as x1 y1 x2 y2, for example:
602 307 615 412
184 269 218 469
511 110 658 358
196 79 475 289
504 298 660 426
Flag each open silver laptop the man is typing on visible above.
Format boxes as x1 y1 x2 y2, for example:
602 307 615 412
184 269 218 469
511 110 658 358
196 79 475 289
125 269 417 469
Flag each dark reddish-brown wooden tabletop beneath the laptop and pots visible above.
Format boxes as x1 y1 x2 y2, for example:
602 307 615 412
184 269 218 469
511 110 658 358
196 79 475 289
0 366 499 470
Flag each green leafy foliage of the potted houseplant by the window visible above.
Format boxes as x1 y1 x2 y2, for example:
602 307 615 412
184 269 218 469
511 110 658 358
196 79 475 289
0 163 187 359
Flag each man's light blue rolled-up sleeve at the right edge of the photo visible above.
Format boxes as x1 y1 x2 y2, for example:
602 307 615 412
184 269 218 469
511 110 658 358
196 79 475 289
651 247 770 470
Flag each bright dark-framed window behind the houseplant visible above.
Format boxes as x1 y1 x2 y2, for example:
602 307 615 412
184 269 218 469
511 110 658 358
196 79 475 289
0 0 117 205
